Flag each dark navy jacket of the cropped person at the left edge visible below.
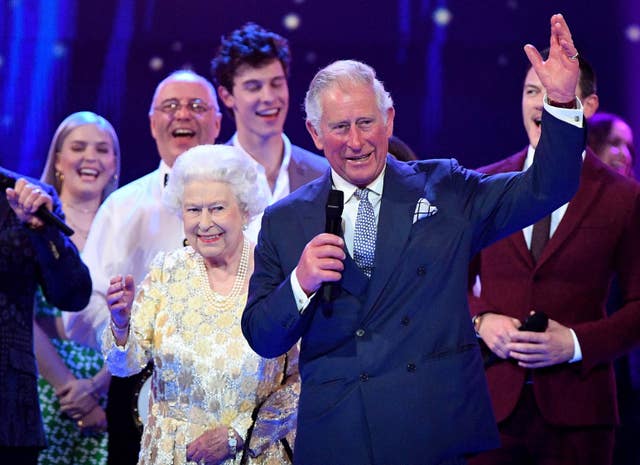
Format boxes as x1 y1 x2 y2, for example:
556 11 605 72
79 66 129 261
0 168 91 447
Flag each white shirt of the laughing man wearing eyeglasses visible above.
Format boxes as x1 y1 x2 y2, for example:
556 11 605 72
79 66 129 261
62 162 185 350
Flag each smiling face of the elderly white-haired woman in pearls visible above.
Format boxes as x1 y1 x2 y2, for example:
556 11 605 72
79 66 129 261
182 180 248 266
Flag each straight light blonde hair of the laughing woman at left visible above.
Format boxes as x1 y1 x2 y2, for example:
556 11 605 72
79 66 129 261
40 111 120 200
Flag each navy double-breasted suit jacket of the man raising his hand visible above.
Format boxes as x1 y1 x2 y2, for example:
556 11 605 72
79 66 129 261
242 113 584 465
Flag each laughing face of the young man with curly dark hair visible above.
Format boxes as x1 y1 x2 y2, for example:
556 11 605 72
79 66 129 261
218 59 289 143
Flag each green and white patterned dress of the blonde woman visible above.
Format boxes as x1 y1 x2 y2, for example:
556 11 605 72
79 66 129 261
36 291 107 465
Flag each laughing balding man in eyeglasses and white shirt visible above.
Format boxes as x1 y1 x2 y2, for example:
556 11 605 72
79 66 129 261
64 70 221 465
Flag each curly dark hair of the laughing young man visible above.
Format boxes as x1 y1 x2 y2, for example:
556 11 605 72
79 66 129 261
211 22 291 93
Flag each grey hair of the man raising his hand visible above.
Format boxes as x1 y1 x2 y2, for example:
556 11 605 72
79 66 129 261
304 60 393 132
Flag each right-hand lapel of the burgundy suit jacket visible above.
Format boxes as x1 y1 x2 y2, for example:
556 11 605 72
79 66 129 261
537 149 604 266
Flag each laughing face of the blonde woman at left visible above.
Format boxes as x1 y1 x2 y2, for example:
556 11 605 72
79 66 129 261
55 124 116 200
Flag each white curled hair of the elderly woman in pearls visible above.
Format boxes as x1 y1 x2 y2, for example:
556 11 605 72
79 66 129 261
162 144 269 220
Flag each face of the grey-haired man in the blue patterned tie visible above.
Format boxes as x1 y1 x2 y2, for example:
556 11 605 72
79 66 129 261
307 83 394 187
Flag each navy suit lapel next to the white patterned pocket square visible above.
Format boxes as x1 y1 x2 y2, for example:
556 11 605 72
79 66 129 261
365 156 426 313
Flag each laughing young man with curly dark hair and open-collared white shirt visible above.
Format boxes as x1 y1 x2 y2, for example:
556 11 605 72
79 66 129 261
211 23 329 234
